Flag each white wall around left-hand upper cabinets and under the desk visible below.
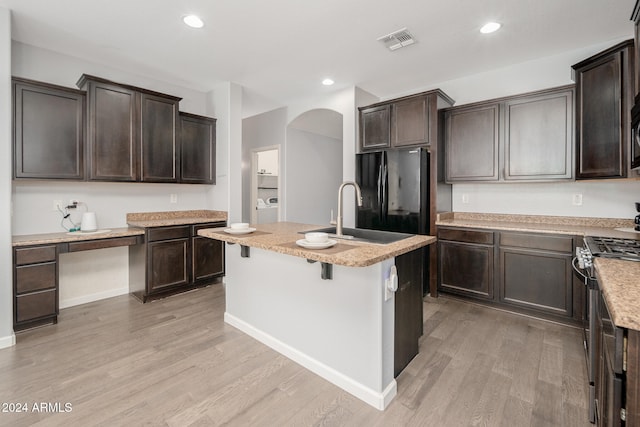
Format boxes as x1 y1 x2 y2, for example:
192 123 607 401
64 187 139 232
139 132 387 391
9 42 230 307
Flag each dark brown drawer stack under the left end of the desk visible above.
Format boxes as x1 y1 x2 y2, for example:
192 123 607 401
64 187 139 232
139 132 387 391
13 245 58 331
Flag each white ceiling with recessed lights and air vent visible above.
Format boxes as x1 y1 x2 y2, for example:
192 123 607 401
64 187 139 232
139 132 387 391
0 0 635 116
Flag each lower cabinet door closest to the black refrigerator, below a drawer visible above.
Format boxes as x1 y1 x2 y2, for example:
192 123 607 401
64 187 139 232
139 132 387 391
438 240 494 300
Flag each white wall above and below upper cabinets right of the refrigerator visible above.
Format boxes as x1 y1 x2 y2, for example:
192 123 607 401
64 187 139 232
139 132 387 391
420 39 640 218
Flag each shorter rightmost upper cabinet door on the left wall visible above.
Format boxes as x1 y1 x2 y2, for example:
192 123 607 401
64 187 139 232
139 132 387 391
180 113 216 184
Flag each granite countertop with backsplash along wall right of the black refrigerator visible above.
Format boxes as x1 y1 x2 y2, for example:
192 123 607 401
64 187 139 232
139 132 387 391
436 212 640 239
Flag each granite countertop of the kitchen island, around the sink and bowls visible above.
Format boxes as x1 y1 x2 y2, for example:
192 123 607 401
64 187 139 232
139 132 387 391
198 222 436 267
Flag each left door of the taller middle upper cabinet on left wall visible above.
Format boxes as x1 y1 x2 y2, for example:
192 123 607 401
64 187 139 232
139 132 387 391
88 81 140 181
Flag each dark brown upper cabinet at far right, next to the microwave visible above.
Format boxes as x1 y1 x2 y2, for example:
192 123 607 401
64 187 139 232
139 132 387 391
573 40 635 179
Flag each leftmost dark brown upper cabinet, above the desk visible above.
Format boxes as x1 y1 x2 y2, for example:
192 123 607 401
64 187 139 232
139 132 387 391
12 77 86 180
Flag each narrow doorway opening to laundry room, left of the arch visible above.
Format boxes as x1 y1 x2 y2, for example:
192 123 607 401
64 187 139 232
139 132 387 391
251 145 282 224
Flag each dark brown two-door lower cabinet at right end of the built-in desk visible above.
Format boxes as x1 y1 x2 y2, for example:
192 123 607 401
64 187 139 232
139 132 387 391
129 222 225 302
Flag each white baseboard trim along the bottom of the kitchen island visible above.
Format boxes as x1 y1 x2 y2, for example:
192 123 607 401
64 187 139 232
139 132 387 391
224 312 398 411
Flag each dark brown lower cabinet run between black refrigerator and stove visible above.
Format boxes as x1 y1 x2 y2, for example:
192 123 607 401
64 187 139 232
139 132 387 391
438 227 584 323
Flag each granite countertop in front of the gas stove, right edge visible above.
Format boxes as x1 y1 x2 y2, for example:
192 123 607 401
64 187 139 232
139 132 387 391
594 258 640 331
